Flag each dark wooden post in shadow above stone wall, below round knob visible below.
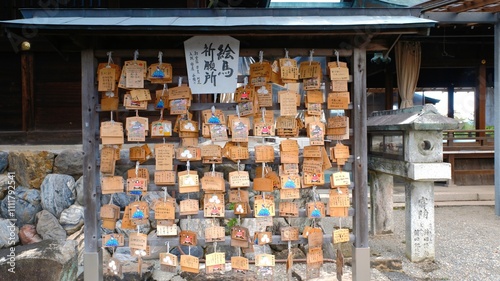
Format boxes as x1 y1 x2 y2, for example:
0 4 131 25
21 51 35 132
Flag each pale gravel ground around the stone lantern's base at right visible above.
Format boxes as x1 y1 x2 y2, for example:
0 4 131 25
370 203 500 281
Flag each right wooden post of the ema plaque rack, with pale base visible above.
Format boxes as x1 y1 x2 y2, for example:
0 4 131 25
352 47 370 281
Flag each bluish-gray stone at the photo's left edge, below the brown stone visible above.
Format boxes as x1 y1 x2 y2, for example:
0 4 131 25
0 186 42 227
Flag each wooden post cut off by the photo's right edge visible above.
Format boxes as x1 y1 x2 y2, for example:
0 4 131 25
493 19 500 216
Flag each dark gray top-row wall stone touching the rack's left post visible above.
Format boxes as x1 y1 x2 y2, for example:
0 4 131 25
54 149 85 180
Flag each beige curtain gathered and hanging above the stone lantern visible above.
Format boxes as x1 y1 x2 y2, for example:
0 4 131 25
395 41 422 108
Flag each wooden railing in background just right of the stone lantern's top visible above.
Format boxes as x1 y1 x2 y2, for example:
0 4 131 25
443 130 494 151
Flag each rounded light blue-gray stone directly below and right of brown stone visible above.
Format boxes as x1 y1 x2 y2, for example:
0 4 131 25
41 174 76 218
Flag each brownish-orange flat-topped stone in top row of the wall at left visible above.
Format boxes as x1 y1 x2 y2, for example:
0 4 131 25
8 151 55 188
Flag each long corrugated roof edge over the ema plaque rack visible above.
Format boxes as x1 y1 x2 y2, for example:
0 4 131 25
1 9 435 30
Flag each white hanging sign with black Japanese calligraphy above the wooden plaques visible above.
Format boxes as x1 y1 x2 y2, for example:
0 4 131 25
184 36 240 94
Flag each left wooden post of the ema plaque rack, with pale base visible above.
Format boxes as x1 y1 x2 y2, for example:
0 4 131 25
81 49 103 281
